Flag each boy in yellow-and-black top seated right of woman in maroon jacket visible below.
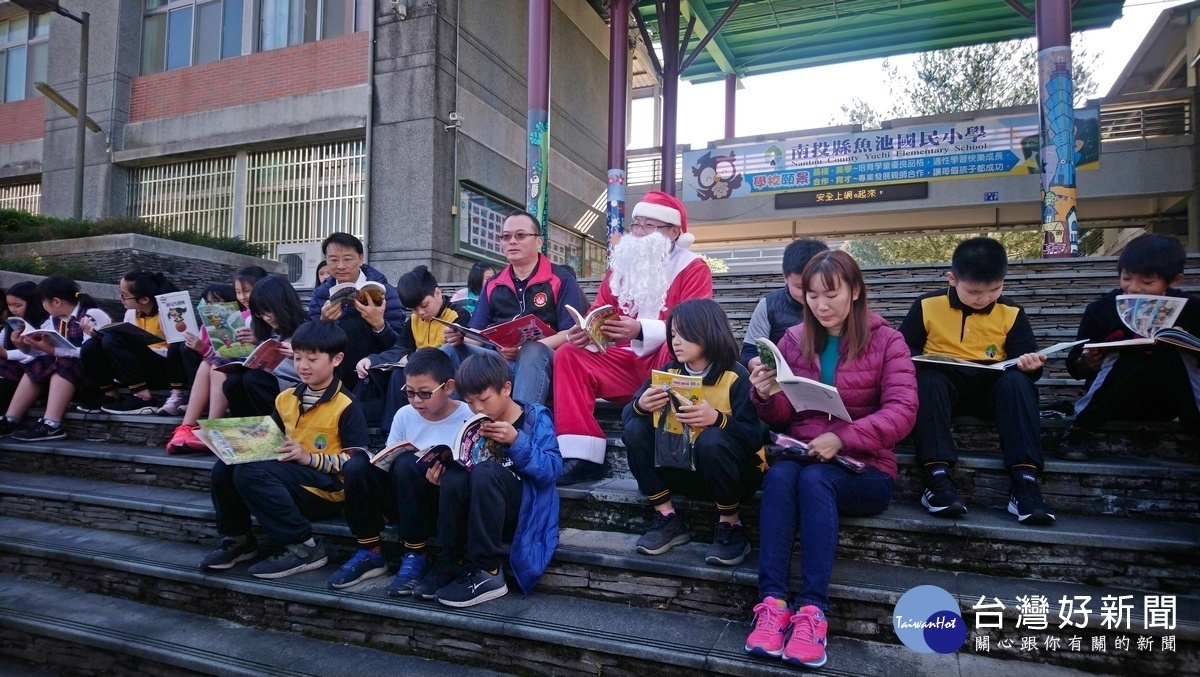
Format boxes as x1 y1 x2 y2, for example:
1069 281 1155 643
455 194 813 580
900 238 1055 526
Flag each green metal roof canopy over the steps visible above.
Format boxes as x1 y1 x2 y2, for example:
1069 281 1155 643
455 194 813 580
635 0 1124 83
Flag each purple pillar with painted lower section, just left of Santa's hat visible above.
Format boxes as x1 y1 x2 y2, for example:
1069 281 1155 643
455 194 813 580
607 0 630 253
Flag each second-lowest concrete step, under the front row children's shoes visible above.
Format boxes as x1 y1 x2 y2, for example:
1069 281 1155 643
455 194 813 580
0 519 1084 677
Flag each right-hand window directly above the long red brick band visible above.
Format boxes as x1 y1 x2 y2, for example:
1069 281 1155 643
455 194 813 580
258 0 355 52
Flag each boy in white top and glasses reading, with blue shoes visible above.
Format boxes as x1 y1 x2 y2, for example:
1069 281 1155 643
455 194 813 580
329 348 472 597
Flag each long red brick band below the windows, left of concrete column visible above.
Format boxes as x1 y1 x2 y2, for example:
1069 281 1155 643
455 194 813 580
129 31 367 123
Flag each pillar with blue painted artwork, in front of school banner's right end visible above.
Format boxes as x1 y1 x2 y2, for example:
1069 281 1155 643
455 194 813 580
1036 0 1079 258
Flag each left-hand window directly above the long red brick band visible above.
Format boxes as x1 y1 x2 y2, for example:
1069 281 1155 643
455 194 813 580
142 0 245 74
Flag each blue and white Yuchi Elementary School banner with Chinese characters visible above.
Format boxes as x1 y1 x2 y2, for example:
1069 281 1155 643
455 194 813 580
683 108 1100 202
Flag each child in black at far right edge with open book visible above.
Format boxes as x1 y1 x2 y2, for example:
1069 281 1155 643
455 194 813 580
1057 233 1200 461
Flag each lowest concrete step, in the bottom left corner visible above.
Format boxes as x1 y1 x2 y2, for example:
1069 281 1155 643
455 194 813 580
0 577 504 677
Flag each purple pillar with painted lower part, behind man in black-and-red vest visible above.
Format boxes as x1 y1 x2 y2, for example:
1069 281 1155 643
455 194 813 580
526 0 551 243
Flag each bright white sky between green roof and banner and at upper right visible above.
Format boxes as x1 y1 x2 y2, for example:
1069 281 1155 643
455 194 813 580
629 0 1187 149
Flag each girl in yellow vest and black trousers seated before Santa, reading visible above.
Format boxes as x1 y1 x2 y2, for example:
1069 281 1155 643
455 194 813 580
620 299 763 567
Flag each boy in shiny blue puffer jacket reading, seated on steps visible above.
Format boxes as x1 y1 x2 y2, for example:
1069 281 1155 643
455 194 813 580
426 353 563 607
